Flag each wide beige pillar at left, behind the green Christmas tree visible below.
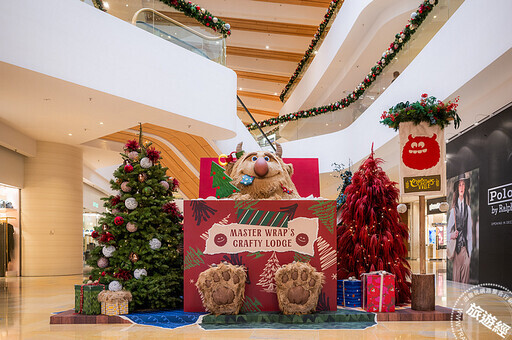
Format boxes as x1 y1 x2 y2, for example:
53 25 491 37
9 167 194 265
21 141 83 276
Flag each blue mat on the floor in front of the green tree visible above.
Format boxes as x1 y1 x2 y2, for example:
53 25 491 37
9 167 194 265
126 310 205 328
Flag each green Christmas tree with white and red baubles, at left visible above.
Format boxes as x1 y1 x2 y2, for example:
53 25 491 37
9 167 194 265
88 129 183 309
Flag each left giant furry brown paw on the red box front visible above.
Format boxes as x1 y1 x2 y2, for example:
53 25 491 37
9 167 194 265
196 263 247 315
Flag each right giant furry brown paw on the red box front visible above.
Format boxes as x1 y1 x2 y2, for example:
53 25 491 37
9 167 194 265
275 262 324 314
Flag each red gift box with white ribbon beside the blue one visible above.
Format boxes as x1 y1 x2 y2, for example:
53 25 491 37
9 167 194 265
361 271 395 312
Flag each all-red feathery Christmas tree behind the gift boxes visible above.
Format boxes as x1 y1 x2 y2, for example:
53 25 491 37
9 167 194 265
338 147 411 304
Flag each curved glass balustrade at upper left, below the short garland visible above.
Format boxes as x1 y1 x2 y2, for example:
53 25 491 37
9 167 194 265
132 8 226 65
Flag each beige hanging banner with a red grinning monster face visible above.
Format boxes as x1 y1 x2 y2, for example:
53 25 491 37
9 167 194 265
399 122 446 196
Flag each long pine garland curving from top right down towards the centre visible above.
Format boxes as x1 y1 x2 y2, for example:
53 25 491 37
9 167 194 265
246 0 438 131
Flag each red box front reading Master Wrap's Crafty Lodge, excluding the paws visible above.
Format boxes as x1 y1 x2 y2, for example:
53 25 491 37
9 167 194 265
183 200 337 312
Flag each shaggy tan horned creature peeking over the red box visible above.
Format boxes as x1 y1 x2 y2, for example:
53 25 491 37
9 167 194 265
226 143 300 200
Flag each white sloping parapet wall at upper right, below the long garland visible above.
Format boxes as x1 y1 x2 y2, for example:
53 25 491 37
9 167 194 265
284 0 512 172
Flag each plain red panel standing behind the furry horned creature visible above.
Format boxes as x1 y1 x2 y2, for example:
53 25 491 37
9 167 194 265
199 158 320 198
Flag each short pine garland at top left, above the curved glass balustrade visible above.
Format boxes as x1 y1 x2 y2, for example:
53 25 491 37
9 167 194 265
160 0 231 38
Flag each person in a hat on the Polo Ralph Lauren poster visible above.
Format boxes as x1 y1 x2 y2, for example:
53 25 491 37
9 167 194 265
448 174 473 283
